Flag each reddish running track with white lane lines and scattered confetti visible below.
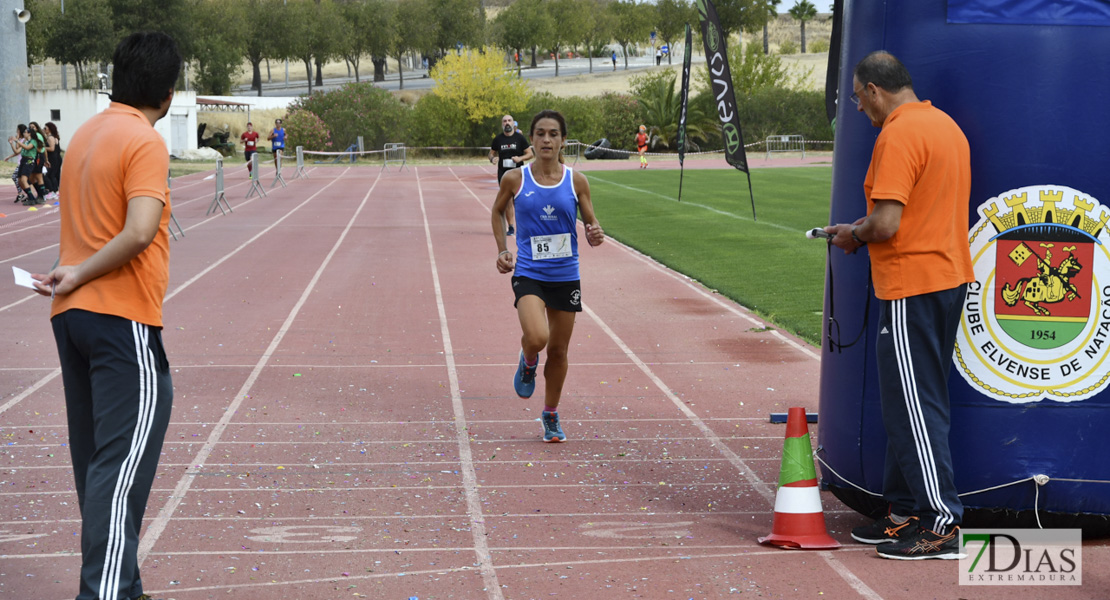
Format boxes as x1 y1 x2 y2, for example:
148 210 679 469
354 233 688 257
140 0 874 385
0 163 1108 600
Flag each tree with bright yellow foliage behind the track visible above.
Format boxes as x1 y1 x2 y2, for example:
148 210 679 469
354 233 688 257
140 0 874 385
432 48 531 124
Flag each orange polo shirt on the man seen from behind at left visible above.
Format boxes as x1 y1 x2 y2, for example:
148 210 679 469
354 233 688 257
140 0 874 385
50 102 170 327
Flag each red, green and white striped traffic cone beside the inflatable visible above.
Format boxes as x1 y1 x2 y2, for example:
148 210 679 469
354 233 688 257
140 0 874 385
759 407 840 550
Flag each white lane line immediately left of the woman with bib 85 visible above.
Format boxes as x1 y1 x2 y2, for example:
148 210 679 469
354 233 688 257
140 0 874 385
413 167 504 600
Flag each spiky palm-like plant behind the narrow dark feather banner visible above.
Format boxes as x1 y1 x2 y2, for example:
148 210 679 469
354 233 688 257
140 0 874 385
636 71 717 150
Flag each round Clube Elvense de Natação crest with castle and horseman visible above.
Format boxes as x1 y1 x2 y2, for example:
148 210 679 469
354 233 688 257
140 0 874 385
953 185 1110 404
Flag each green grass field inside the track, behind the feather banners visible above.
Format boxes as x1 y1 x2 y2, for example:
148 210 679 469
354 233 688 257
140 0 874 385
587 166 839 344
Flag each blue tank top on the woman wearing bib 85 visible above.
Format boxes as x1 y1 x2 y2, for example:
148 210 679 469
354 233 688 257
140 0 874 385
513 164 581 282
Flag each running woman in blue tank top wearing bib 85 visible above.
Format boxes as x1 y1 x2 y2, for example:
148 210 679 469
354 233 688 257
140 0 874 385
491 110 605 443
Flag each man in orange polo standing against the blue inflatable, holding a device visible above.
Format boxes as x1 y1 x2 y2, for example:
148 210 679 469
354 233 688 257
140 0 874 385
825 51 975 560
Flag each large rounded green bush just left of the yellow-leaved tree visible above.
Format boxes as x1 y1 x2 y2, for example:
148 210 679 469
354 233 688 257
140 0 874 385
292 82 410 150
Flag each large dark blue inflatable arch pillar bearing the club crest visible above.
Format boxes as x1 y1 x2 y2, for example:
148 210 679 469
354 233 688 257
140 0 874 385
817 0 1110 536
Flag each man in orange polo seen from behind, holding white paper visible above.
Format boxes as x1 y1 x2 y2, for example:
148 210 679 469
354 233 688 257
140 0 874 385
34 33 182 600
